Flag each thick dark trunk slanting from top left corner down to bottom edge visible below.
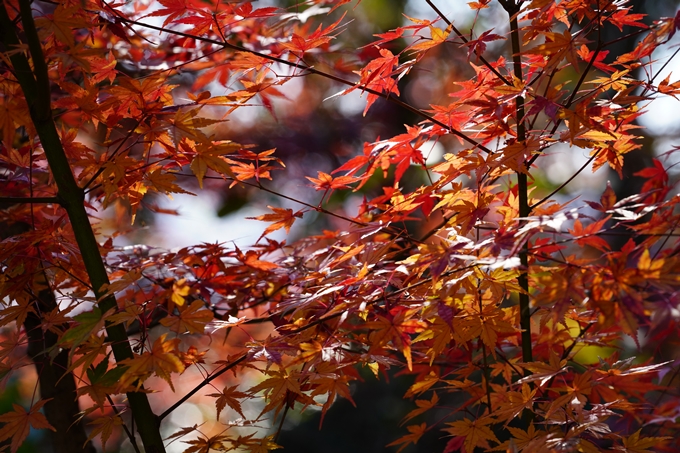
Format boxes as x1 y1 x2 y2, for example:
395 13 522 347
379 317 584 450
0 4 165 453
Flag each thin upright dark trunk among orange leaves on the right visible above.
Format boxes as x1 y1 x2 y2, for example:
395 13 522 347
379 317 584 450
501 2 533 368
